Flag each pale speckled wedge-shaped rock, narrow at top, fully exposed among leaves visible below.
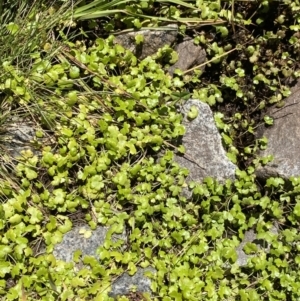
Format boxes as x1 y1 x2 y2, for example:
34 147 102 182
175 99 236 198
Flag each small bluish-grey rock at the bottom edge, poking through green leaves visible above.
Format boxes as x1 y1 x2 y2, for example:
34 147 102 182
109 267 156 297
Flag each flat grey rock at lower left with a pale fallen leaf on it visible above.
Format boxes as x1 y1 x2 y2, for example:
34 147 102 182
53 225 127 262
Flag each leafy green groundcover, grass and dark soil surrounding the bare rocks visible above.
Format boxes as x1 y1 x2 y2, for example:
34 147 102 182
0 0 300 301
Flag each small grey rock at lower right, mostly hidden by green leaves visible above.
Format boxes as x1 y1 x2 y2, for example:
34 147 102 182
236 224 278 267
